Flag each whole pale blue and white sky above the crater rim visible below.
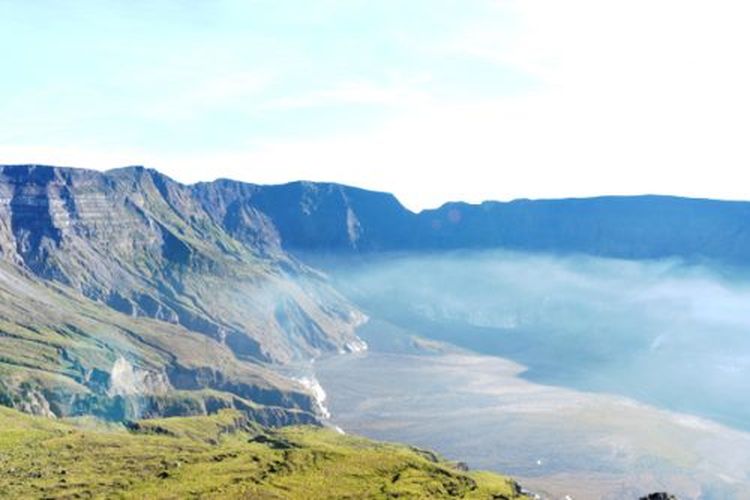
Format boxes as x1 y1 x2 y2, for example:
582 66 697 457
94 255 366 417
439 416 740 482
0 0 750 210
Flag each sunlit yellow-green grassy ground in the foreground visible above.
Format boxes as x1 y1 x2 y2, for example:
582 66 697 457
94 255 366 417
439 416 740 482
0 408 521 499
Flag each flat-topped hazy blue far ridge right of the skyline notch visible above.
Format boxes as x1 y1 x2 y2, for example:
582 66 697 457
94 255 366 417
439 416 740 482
418 196 750 264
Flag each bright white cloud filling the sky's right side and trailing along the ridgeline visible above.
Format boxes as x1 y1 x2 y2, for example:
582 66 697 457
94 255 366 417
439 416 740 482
5 0 750 208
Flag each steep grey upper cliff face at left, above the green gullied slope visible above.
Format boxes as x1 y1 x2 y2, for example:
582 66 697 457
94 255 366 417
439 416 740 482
0 166 364 362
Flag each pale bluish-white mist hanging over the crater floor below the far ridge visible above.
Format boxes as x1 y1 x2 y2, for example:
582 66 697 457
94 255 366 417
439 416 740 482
320 251 750 431
